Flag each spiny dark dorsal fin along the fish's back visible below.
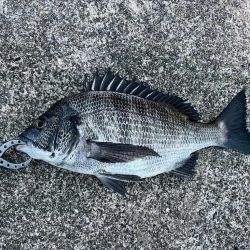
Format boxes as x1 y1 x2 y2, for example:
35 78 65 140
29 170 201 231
86 69 200 121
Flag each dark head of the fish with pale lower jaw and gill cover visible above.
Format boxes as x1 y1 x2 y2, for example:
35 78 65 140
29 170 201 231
17 102 79 165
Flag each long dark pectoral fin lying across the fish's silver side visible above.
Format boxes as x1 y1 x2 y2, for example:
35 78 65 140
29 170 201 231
87 141 159 163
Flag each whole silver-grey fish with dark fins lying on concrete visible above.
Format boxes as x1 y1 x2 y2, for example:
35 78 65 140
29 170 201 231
17 70 250 195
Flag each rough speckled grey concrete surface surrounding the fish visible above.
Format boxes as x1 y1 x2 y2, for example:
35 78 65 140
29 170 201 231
0 0 250 250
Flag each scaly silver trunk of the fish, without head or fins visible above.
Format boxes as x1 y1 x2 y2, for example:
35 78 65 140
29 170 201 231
63 91 221 178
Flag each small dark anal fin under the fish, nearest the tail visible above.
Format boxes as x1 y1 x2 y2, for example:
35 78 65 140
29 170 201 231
170 152 199 178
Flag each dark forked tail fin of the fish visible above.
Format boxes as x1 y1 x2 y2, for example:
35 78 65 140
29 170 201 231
215 89 250 154
